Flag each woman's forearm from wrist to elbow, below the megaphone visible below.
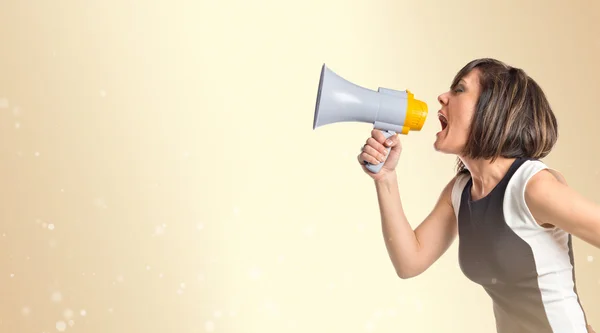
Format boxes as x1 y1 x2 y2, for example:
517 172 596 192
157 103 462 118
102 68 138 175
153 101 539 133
375 173 419 278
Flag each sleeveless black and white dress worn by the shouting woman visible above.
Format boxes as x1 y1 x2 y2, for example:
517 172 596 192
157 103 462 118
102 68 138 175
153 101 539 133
452 159 587 333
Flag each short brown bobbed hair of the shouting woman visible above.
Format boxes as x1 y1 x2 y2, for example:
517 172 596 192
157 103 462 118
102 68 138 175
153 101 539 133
452 58 558 173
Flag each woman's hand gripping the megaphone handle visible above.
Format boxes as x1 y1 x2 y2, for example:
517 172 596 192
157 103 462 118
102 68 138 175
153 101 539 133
357 129 402 180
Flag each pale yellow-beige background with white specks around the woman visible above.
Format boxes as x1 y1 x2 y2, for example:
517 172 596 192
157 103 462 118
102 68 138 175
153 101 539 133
0 0 600 333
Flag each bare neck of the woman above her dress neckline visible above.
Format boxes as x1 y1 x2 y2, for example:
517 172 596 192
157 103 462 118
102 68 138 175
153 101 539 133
461 157 515 200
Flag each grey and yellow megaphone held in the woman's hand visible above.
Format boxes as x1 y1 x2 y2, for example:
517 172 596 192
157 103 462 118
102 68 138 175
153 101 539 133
313 64 428 173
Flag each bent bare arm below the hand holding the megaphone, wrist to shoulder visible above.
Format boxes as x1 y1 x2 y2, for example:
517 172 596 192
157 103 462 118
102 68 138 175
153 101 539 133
375 172 457 279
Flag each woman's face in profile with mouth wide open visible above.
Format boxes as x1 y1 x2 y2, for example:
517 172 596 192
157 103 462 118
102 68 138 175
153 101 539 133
433 68 481 155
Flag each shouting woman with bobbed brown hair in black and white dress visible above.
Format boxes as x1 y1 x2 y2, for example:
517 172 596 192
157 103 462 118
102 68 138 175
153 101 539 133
358 59 600 333
